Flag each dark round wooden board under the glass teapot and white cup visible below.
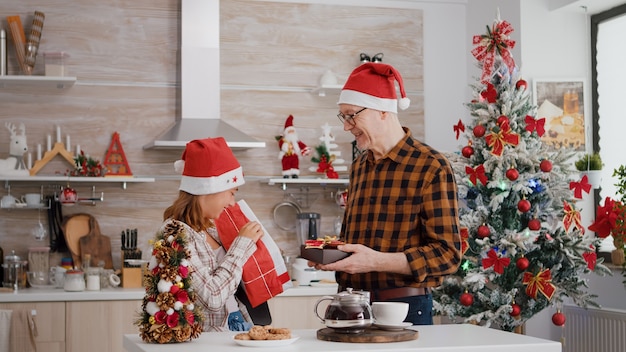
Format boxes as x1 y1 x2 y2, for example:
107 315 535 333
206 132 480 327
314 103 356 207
317 327 419 343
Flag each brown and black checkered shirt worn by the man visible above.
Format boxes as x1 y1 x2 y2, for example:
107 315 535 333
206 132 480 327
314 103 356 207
337 128 461 291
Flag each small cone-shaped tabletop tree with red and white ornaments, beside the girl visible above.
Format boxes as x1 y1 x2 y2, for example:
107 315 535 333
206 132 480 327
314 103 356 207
136 221 203 344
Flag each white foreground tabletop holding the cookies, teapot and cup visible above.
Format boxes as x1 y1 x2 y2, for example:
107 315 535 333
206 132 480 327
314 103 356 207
123 324 561 352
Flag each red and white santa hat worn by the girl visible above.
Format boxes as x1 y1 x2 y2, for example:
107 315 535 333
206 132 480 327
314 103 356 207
174 137 245 195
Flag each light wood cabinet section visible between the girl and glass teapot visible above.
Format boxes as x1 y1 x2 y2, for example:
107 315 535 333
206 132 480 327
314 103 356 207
268 296 330 329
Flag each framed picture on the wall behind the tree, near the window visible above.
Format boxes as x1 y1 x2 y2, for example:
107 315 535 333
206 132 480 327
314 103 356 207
533 79 585 151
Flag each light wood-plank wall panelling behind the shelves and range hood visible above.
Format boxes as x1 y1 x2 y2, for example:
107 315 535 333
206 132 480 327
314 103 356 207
0 0 424 267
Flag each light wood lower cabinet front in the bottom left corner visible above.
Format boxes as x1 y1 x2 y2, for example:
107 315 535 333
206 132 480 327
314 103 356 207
0 302 65 352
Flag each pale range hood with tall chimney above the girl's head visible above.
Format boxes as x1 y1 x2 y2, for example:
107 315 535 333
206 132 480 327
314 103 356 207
144 0 265 150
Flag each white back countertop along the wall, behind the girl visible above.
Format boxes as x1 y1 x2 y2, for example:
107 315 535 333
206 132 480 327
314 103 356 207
0 285 337 303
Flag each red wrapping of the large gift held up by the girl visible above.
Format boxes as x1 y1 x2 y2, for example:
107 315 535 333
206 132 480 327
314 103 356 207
215 204 290 307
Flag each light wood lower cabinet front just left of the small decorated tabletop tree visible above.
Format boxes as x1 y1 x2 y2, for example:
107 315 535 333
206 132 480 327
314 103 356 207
65 300 141 352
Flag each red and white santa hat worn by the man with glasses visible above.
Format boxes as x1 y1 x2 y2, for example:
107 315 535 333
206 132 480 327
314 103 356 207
337 62 411 113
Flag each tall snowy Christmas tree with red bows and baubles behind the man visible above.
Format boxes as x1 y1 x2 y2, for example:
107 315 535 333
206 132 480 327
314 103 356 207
433 16 609 331
